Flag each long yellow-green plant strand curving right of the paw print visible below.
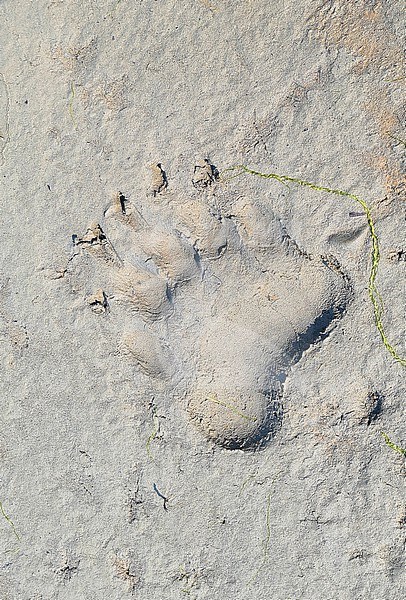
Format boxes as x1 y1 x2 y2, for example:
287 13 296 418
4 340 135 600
224 165 406 367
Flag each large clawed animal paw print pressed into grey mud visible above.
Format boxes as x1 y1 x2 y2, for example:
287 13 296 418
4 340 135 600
68 161 351 449
